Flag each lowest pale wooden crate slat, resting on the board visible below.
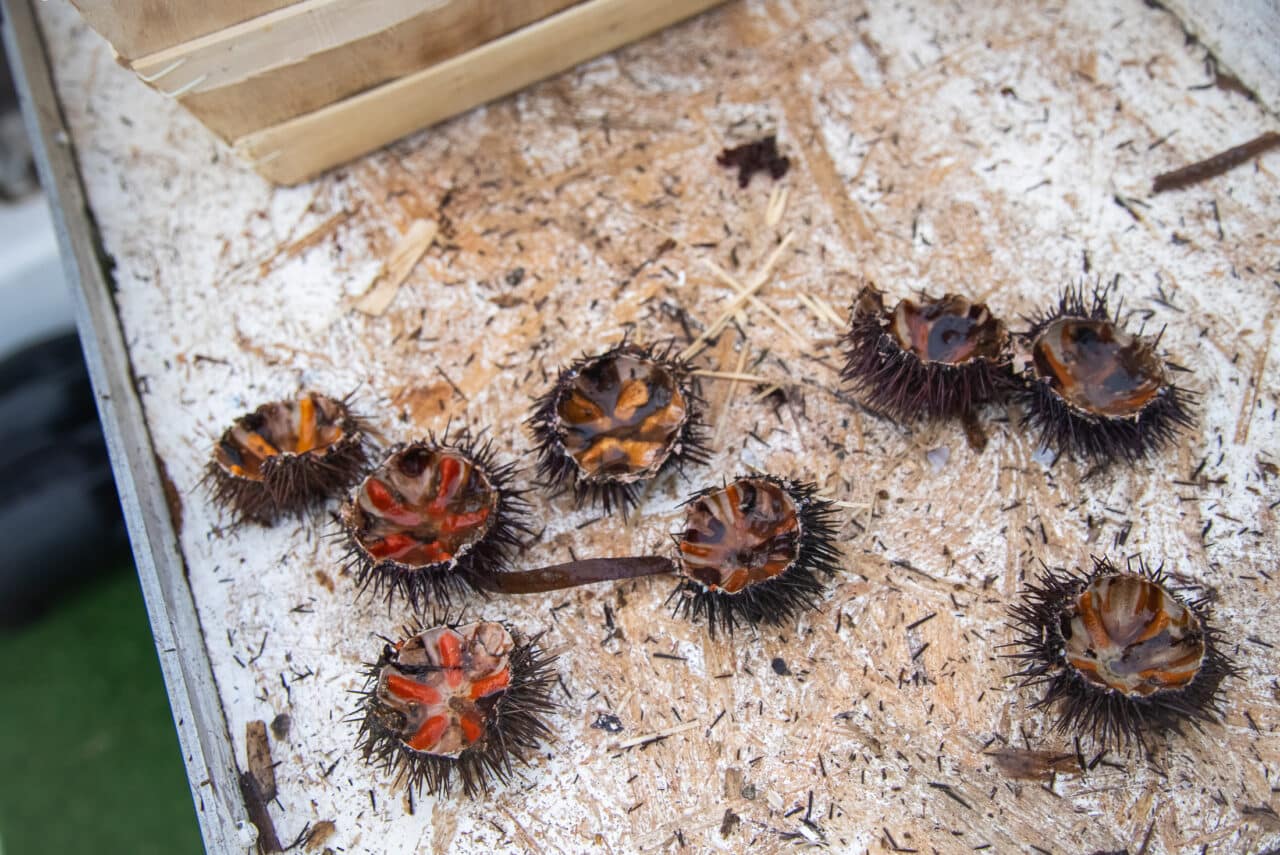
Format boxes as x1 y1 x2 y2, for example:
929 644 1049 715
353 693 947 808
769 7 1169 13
234 0 723 184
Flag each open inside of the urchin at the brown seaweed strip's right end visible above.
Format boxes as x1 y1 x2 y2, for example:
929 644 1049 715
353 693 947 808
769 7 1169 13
680 477 800 594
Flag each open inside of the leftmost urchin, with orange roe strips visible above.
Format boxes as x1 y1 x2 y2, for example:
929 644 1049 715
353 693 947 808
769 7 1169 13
214 394 346 481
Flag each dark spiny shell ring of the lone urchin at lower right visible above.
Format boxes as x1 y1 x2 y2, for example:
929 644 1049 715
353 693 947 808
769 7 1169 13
1009 555 1239 747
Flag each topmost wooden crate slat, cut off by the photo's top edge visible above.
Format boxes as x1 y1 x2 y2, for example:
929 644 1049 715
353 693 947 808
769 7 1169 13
72 0 296 60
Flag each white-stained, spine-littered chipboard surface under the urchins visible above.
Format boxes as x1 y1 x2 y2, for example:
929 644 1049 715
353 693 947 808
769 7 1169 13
42 1 1280 852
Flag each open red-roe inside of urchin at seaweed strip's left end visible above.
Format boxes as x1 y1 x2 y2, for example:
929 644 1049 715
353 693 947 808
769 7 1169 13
353 447 498 567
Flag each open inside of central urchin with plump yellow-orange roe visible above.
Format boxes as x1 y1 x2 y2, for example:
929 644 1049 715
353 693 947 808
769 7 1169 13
556 353 689 480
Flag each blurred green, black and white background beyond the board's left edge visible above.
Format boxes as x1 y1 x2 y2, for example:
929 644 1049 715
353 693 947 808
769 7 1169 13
0 19 201 855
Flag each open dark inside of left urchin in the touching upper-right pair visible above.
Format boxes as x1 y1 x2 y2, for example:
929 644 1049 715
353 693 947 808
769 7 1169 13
890 294 1001 365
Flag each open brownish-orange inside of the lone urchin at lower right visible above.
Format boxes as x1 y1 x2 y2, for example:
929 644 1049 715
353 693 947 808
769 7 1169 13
1062 575 1204 696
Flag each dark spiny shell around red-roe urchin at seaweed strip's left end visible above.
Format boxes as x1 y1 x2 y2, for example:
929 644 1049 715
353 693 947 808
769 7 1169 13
339 430 532 611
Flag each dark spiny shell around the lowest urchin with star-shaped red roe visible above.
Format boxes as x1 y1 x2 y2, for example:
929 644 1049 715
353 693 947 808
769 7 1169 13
353 621 556 799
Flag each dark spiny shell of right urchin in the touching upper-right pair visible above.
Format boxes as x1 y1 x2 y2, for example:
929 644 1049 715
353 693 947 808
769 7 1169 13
1009 279 1196 465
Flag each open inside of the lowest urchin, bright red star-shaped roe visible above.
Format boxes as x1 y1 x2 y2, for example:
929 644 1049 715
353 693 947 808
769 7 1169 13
374 622 515 756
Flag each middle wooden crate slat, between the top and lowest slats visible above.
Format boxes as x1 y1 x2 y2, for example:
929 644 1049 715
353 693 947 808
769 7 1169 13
149 0 582 140
